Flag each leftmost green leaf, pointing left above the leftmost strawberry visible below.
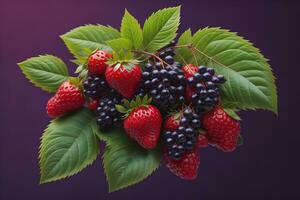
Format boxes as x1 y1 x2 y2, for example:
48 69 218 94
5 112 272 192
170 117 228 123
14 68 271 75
18 55 69 92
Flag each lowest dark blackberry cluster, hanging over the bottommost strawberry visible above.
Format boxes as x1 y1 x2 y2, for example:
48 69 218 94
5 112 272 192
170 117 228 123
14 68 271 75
163 108 201 160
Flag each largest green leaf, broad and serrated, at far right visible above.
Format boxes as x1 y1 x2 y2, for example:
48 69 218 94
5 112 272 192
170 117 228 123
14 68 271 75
193 28 277 113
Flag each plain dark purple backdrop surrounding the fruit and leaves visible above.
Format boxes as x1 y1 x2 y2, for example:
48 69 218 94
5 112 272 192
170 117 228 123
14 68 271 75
0 0 300 200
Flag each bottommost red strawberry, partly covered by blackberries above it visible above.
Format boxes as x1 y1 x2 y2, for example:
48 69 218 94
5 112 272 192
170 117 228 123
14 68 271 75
163 148 200 180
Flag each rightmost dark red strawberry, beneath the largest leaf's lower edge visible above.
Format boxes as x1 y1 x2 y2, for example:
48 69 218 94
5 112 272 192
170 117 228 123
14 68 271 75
202 107 241 152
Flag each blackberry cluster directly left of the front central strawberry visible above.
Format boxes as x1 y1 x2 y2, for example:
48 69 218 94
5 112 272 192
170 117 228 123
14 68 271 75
95 93 122 130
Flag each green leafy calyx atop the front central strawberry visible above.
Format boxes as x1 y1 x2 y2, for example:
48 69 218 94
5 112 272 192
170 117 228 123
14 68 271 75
116 95 152 118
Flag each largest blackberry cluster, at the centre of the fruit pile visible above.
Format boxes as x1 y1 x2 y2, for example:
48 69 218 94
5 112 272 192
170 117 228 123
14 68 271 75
137 62 186 111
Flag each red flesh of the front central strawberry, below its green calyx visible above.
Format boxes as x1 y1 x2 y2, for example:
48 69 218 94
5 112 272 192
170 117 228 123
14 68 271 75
124 105 162 149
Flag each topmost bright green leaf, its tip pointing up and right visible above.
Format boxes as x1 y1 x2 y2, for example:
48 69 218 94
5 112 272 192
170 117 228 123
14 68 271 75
143 6 180 52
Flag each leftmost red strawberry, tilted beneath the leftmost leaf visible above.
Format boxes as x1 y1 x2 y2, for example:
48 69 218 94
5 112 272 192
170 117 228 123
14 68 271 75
46 81 84 117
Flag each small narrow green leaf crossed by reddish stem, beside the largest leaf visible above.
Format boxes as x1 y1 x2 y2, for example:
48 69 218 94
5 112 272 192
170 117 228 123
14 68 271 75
175 29 193 64
